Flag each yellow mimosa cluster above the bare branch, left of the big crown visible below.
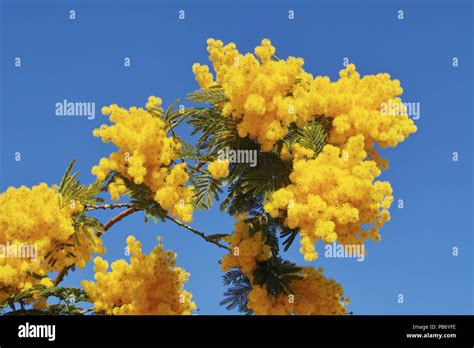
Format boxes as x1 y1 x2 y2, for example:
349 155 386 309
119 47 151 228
92 96 193 221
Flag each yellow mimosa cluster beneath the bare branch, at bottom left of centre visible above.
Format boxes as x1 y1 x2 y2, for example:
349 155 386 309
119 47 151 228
82 236 196 315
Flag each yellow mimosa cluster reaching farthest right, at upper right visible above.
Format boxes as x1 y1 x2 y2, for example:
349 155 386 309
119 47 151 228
314 64 416 149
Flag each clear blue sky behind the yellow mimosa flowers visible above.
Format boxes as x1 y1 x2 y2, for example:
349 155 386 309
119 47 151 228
0 0 473 314
